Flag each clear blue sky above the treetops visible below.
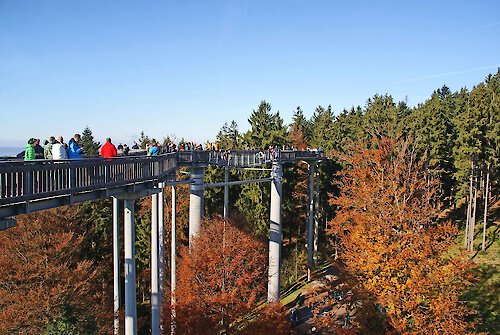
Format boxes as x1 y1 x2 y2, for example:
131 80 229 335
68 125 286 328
0 0 500 146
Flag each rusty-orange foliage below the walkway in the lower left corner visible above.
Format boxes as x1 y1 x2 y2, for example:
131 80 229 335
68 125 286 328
0 207 109 334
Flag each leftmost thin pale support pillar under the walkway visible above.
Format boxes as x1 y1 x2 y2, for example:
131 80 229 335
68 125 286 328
113 197 120 335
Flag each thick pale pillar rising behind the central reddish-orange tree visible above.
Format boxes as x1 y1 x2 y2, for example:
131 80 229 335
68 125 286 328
189 167 205 246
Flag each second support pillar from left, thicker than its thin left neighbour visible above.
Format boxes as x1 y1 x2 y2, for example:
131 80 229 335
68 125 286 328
123 199 137 335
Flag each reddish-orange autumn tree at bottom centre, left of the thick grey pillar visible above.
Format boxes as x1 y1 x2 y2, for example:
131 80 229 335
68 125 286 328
171 218 289 335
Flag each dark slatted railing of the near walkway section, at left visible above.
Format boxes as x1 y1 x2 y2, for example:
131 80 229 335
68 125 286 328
0 153 177 205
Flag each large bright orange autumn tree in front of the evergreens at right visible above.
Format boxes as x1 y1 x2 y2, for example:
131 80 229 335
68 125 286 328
328 138 480 335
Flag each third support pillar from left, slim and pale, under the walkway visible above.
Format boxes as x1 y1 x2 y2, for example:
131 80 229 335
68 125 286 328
151 194 160 335
